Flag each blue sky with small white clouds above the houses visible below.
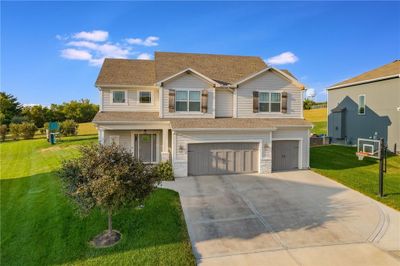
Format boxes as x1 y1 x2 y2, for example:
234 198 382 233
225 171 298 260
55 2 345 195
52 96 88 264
1 1 400 105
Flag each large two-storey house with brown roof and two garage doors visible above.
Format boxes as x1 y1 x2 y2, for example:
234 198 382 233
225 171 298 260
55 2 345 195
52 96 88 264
93 52 312 177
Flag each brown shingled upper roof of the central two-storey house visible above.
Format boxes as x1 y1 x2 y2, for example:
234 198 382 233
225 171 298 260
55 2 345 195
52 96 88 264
96 52 267 86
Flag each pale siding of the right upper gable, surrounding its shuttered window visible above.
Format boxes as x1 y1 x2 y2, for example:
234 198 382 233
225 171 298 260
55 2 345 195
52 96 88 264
237 71 303 118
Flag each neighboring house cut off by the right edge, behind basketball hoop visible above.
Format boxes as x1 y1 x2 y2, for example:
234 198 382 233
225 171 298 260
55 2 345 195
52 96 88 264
328 60 400 151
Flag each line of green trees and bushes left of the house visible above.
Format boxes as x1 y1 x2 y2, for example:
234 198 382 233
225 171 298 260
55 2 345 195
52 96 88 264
0 92 99 140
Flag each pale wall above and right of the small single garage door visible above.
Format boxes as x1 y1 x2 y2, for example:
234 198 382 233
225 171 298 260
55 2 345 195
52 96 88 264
272 128 310 169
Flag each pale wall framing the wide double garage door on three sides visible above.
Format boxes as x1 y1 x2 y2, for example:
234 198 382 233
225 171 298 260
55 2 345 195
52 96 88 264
172 131 271 176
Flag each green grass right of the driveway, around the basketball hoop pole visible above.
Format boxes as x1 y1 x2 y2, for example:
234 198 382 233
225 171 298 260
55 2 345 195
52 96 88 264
310 145 400 210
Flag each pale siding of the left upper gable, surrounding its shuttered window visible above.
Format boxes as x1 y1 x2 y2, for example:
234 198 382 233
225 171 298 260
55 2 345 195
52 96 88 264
163 74 215 118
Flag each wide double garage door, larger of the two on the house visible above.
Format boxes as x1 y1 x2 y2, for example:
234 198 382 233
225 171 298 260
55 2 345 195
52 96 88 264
188 143 258 175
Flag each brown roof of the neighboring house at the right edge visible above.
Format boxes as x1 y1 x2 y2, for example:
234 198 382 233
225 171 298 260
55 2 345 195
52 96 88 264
328 60 400 89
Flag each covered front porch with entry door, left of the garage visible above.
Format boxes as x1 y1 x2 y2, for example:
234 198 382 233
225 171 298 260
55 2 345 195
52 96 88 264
98 123 171 164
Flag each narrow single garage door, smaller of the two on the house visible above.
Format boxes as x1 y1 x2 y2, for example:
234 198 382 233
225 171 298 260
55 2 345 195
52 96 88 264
272 140 299 171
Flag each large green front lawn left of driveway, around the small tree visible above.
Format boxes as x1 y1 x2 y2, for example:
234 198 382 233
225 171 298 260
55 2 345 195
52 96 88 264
0 136 194 265
